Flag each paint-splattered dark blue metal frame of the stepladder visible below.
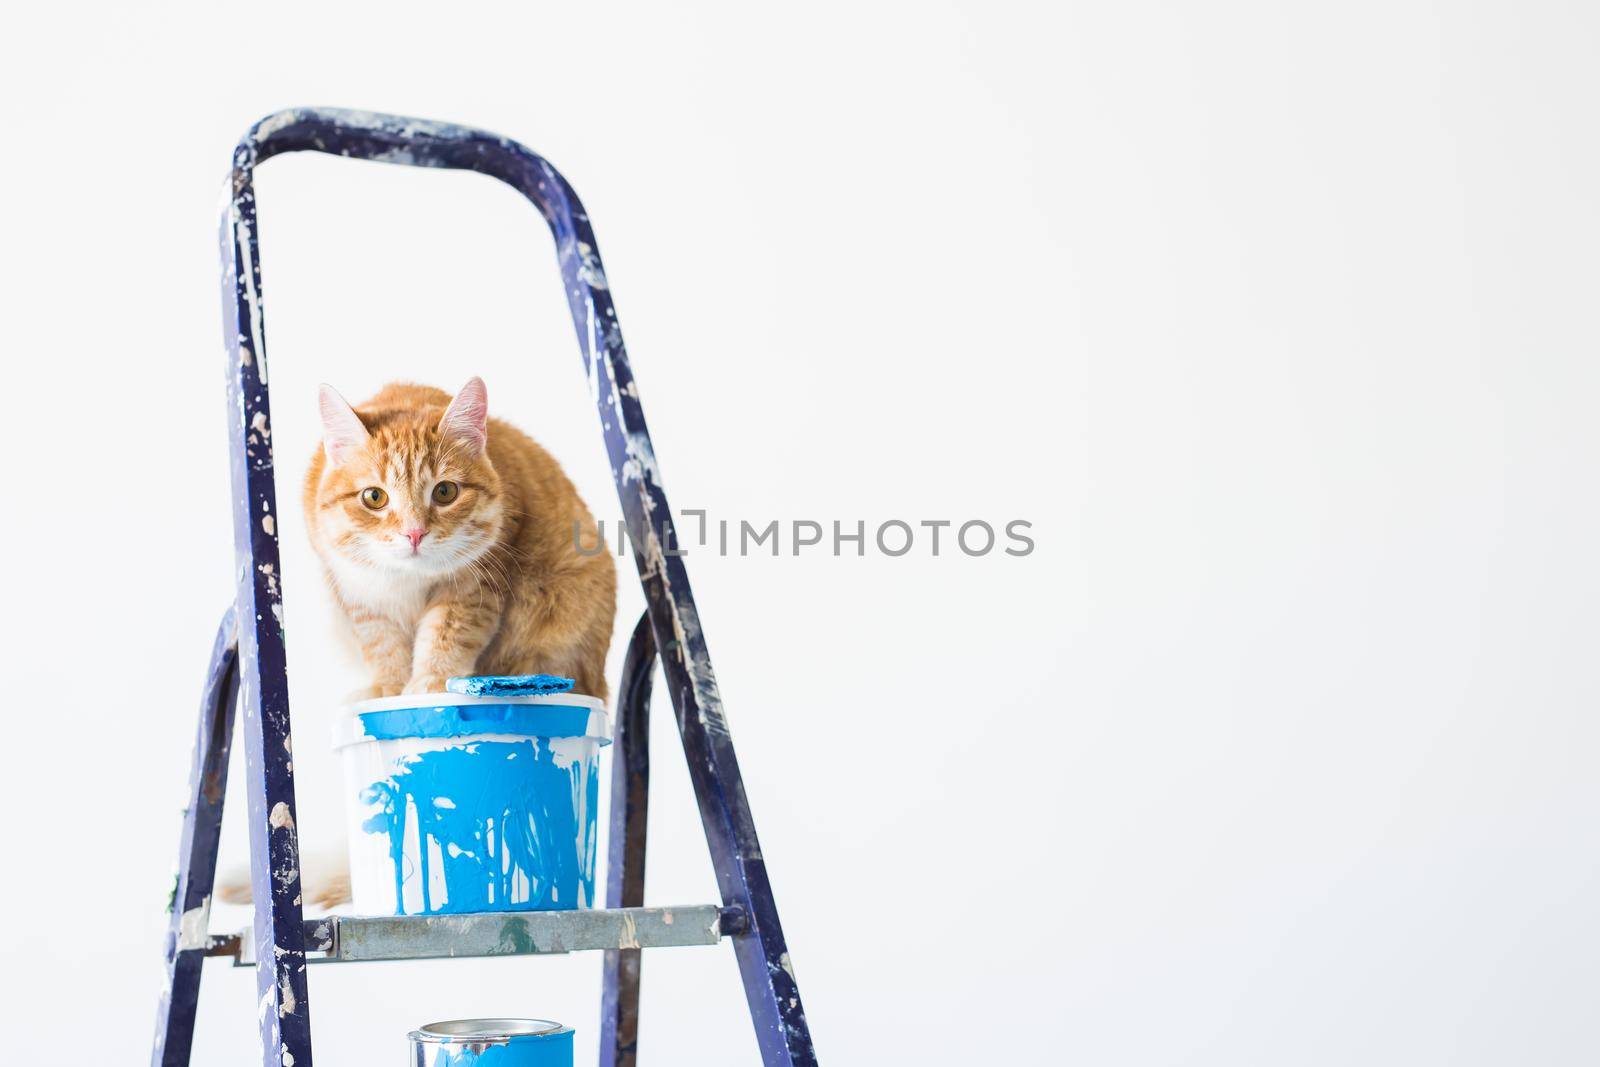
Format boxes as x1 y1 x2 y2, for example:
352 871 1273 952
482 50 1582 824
152 109 816 1067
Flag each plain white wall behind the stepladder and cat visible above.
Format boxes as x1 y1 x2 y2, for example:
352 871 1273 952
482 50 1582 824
0 0 1600 1067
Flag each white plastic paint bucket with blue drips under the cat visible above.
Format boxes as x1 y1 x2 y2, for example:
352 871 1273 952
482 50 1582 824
334 693 611 915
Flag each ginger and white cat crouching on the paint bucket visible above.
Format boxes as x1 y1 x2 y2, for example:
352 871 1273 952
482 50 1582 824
306 378 616 699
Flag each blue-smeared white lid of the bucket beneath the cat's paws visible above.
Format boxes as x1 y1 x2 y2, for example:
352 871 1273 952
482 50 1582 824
333 693 611 749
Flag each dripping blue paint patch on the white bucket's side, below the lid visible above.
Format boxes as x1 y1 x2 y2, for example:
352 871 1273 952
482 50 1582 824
362 737 600 915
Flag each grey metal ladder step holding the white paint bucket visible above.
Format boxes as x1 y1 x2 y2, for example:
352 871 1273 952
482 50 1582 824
219 904 732 966
